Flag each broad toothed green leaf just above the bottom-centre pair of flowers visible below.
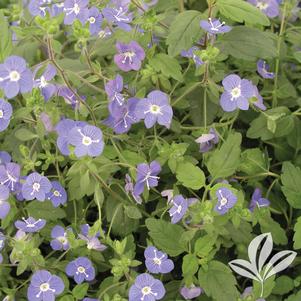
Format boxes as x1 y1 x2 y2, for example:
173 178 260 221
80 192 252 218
145 218 186 256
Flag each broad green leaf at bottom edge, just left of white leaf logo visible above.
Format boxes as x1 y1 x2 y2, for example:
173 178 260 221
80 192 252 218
198 260 238 301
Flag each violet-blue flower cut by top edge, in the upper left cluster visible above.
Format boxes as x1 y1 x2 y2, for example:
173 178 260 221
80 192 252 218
64 0 89 25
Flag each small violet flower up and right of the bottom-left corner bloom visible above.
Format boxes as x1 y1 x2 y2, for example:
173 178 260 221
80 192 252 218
66 257 95 284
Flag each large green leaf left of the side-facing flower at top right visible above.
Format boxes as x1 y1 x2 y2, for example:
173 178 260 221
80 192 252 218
166 10 202 56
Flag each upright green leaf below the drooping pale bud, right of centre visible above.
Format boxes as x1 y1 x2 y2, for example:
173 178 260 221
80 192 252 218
207 133 241 179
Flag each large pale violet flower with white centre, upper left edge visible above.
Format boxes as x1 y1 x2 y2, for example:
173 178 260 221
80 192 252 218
0 55 33 98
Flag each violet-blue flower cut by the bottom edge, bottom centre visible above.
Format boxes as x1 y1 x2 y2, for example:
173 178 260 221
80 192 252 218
129 273 165 301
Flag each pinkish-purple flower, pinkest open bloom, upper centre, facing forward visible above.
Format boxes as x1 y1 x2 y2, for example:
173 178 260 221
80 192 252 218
114 41 145 72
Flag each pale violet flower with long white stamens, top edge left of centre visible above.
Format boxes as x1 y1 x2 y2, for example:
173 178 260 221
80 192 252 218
102 0 133 31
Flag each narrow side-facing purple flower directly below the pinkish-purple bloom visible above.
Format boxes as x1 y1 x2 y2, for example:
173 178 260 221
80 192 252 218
105 74 125 114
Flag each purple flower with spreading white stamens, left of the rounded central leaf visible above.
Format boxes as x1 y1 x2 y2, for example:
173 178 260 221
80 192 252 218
134 161 161 195
